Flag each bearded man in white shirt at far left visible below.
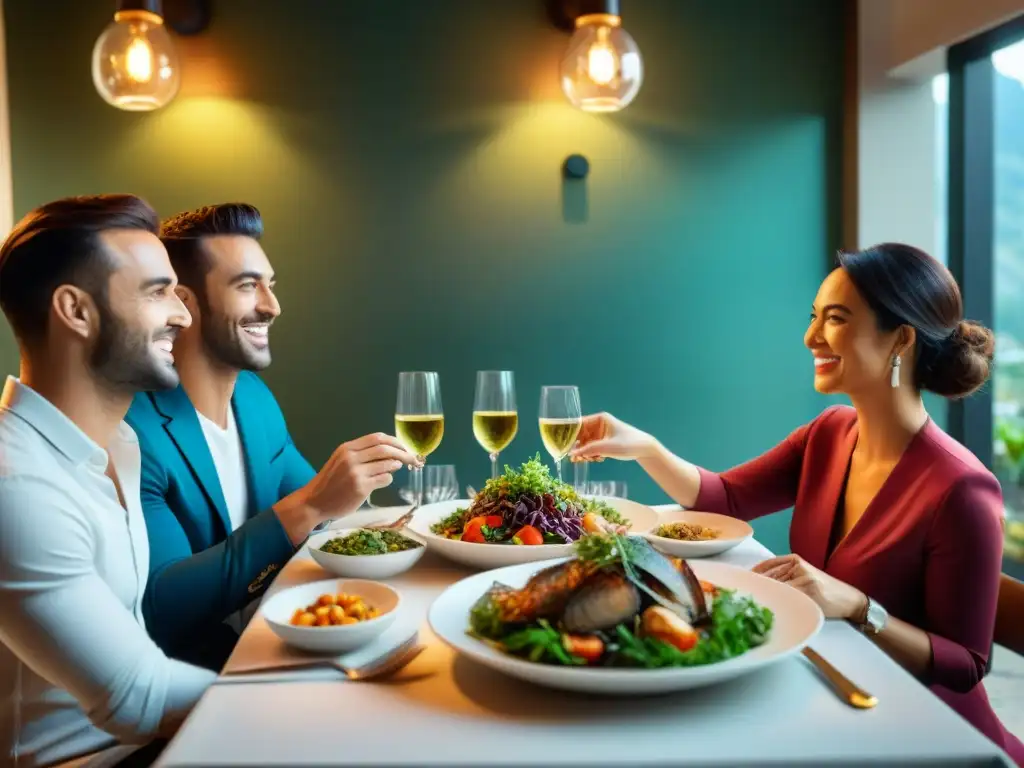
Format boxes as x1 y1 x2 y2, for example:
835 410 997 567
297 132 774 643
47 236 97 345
0 195 213 766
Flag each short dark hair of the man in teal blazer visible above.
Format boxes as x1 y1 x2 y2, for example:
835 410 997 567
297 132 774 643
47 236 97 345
160 203 263 296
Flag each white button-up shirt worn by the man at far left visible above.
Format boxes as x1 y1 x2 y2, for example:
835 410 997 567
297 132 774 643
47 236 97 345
0 378 215 766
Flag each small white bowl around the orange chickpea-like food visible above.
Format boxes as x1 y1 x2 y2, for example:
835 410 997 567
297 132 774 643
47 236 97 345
260 579 401 654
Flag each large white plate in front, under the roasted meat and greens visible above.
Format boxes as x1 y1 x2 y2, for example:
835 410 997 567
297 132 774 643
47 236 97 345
428 560 824 696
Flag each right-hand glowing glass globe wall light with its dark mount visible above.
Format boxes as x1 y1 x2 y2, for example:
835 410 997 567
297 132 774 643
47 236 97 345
547 0 643 112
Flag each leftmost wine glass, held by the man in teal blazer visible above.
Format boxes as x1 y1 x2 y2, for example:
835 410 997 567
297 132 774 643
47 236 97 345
394 371 444 505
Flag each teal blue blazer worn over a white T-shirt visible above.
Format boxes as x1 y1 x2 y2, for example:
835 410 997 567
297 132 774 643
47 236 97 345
126 372 315 668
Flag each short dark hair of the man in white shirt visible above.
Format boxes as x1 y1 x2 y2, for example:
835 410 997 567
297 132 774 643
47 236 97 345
0 195 160 343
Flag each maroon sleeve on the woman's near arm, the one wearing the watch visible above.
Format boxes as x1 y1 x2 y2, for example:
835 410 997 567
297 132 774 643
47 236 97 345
925 473 1002 693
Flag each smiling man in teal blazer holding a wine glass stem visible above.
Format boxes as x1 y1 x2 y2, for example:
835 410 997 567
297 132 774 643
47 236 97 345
127 204 417 669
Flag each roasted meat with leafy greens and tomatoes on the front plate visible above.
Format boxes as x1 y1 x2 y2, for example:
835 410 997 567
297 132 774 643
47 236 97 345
468 534 774 669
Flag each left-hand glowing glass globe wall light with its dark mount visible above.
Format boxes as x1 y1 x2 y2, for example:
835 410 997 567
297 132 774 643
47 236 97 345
92 0 210 112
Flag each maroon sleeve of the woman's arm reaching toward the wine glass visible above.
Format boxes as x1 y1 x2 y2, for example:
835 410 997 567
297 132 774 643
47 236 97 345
693 407 836 520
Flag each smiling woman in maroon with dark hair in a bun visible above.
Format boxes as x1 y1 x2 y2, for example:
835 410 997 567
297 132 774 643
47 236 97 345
573 244 1024 766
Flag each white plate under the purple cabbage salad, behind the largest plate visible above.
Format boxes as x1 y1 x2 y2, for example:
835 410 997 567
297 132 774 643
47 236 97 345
408 497 659 568
